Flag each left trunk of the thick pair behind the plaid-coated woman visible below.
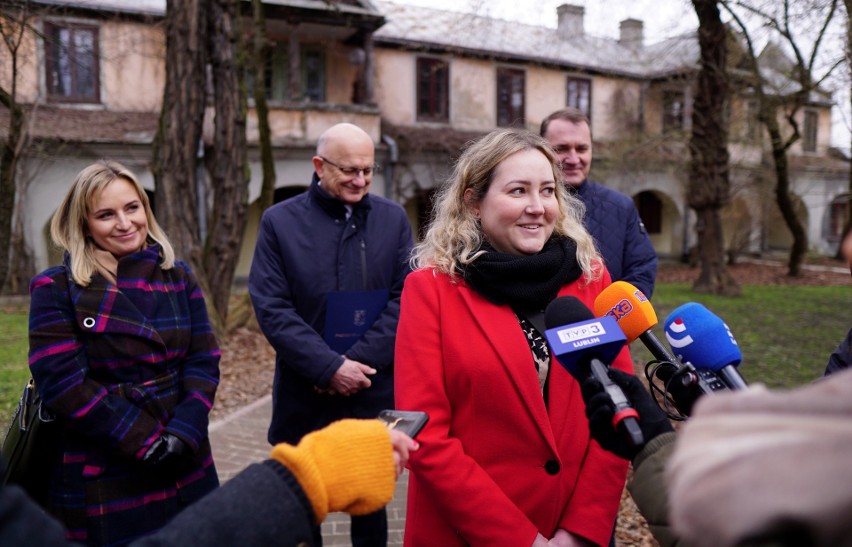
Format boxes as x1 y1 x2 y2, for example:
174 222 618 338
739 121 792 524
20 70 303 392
152 0 209 276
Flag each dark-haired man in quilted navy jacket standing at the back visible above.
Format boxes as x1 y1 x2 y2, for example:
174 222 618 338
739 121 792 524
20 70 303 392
541 108 657 298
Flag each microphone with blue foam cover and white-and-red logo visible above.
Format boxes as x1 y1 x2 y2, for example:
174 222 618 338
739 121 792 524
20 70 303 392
664 302 748 390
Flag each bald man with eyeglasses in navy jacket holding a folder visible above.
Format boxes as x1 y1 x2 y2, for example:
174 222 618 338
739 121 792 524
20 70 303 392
249 123 413 546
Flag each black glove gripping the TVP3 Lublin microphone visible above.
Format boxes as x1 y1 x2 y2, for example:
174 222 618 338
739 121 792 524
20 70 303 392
581 368 674 460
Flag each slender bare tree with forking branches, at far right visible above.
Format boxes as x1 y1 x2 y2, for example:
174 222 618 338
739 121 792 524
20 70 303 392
719 0 841 277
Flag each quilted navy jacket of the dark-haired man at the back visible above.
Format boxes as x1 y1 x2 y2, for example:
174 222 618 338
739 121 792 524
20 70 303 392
575 179 657 298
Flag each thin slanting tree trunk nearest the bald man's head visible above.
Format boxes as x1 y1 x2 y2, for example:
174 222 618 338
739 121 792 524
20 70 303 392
251 0 274 214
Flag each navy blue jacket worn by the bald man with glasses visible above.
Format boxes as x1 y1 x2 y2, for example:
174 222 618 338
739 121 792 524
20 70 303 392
249 174 413 444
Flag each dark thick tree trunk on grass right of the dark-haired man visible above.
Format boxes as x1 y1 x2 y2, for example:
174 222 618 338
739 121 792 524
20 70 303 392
687 0 741 295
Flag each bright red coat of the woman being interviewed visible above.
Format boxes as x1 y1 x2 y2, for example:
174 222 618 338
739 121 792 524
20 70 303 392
395 269 633 547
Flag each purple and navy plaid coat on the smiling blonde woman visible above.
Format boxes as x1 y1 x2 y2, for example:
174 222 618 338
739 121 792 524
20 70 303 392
29 245 220 545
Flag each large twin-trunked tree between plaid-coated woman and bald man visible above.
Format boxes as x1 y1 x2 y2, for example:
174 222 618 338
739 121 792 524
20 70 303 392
152 0 249 334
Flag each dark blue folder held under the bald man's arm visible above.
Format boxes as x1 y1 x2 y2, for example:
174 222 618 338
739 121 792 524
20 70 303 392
324 289 388 354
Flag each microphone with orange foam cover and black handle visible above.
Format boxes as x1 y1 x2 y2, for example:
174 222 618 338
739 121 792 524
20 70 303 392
595 281 726 416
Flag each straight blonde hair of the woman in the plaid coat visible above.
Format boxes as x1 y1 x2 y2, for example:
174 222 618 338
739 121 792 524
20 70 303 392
50 160 175 287
